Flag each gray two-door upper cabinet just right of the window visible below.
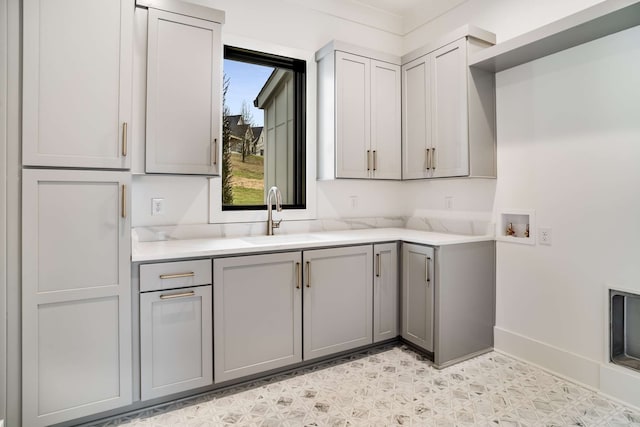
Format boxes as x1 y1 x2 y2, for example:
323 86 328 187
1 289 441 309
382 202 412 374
316 41 402 179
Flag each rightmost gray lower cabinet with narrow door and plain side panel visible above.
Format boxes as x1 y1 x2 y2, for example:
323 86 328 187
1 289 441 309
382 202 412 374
402 241 495 368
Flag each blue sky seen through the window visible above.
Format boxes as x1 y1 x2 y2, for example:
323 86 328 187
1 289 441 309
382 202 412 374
224 59 273 126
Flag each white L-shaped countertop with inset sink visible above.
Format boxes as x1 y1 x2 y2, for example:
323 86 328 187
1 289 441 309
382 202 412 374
131 228 494 262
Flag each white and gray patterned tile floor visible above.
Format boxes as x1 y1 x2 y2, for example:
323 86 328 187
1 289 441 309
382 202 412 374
94 346 640 427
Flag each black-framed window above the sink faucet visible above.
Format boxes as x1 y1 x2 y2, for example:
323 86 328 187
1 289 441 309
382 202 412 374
221 46 306 210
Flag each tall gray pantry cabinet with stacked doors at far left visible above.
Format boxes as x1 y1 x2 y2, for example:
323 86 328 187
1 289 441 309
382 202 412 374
22 0 134 427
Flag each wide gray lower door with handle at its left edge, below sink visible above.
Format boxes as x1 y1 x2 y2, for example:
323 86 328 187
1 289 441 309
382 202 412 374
303 245 373 360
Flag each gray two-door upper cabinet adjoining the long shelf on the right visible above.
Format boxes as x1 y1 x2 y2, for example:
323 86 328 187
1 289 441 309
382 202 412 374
402 28 496 179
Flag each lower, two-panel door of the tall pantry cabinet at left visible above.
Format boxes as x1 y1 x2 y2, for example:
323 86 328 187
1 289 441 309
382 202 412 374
22 170 132 426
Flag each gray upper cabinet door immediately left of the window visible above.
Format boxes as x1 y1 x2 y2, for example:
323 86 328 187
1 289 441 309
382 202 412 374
146 8 222 175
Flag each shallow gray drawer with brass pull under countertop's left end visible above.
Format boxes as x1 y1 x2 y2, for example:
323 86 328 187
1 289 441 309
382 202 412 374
140 259 211 292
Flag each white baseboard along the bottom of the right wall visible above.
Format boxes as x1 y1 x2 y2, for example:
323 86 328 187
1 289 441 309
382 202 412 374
494 326 640 411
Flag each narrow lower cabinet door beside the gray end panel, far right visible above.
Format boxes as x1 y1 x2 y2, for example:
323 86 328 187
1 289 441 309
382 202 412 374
402 243 435 352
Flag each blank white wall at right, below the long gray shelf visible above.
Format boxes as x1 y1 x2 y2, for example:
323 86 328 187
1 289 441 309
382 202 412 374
496 27 640 402
